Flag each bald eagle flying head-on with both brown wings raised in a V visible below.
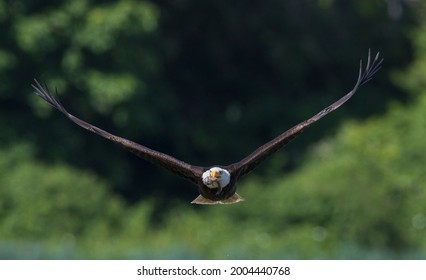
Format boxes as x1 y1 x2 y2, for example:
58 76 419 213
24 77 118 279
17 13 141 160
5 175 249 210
32 51 383 204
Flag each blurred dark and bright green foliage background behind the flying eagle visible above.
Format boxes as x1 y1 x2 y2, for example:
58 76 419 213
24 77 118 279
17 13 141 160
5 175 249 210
0 0 426 259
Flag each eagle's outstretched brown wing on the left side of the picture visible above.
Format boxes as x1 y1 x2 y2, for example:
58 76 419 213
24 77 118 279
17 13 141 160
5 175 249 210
32 79 203 183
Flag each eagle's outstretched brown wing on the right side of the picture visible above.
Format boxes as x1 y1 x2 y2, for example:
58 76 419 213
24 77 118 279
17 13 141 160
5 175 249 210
225 50 383 177
